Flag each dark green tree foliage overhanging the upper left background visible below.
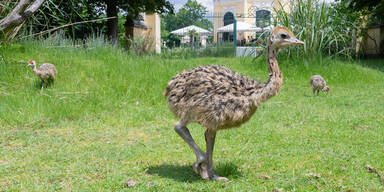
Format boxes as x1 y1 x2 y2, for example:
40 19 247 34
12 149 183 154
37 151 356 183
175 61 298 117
6 0 173 41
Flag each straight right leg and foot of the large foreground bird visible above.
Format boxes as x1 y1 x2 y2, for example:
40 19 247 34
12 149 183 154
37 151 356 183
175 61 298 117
206 129 228 181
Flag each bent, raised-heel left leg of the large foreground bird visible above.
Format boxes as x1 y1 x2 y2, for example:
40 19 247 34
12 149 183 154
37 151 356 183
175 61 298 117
175 122 208 179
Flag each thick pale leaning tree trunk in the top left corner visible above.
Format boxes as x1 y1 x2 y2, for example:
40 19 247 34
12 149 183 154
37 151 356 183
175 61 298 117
0 0 45 41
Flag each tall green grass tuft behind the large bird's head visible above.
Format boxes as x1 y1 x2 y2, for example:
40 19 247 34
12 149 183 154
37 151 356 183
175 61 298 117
274 0 360 58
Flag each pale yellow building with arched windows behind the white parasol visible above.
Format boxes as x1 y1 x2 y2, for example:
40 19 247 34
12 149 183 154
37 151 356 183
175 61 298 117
213 0 289 42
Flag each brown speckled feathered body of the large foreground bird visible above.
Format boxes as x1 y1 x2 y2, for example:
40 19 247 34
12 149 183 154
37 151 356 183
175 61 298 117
164 65 266 130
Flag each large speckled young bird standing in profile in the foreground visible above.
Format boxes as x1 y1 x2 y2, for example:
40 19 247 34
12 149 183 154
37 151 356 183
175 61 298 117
164 27 304 181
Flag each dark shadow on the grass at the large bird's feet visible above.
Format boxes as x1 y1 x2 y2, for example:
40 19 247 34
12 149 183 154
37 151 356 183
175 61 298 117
147 163 241 182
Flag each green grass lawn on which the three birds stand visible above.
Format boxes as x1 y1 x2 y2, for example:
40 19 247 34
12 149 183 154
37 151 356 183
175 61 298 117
0 44 384 191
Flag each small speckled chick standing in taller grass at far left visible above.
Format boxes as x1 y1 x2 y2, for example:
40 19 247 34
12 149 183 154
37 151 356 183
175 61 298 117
28 60 57 90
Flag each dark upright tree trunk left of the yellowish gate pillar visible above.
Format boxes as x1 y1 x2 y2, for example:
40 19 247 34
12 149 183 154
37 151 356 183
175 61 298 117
107 0 118 45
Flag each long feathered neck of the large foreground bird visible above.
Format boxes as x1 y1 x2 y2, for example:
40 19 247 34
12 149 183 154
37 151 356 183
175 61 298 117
258 39 283 102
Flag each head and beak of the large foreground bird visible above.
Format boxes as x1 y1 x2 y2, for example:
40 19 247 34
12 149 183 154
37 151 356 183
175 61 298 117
270 27 304 49
